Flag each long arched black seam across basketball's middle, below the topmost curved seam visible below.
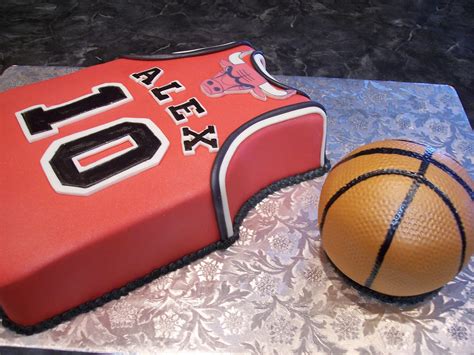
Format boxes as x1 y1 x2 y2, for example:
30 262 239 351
320 169 466 272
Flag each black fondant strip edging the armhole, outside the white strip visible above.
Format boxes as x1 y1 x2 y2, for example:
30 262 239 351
211 101 329 240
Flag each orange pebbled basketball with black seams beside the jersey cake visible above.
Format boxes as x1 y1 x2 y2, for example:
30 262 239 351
318 140 474 297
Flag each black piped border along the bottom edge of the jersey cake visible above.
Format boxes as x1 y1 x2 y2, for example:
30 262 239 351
0 161 329 335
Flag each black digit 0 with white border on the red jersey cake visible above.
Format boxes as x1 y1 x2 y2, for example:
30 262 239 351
41 118 170 196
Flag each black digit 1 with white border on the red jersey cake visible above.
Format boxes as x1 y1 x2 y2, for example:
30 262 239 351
15 83 133 143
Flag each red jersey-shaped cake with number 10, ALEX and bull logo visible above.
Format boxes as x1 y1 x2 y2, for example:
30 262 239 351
0 42 327 334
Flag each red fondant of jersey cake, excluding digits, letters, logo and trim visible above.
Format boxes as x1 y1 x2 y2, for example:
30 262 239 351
0 46 322 325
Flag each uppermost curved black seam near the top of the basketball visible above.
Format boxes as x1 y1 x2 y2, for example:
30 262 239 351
333 147 474 200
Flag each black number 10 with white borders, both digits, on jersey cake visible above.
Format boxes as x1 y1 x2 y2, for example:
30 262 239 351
16 83 169 196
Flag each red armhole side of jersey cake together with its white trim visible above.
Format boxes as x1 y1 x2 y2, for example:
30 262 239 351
212 105 328 240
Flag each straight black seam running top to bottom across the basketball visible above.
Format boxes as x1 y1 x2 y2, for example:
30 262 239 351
364 147 435 287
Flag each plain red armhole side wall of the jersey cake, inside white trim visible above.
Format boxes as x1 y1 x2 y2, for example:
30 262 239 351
226 114 324 219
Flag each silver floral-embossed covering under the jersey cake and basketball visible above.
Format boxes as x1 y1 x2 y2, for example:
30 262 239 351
0 67 474 354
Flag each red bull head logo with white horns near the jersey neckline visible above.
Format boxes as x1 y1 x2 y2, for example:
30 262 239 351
201 51 296 101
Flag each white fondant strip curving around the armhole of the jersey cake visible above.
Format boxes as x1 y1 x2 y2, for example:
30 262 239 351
219 107 327 236
